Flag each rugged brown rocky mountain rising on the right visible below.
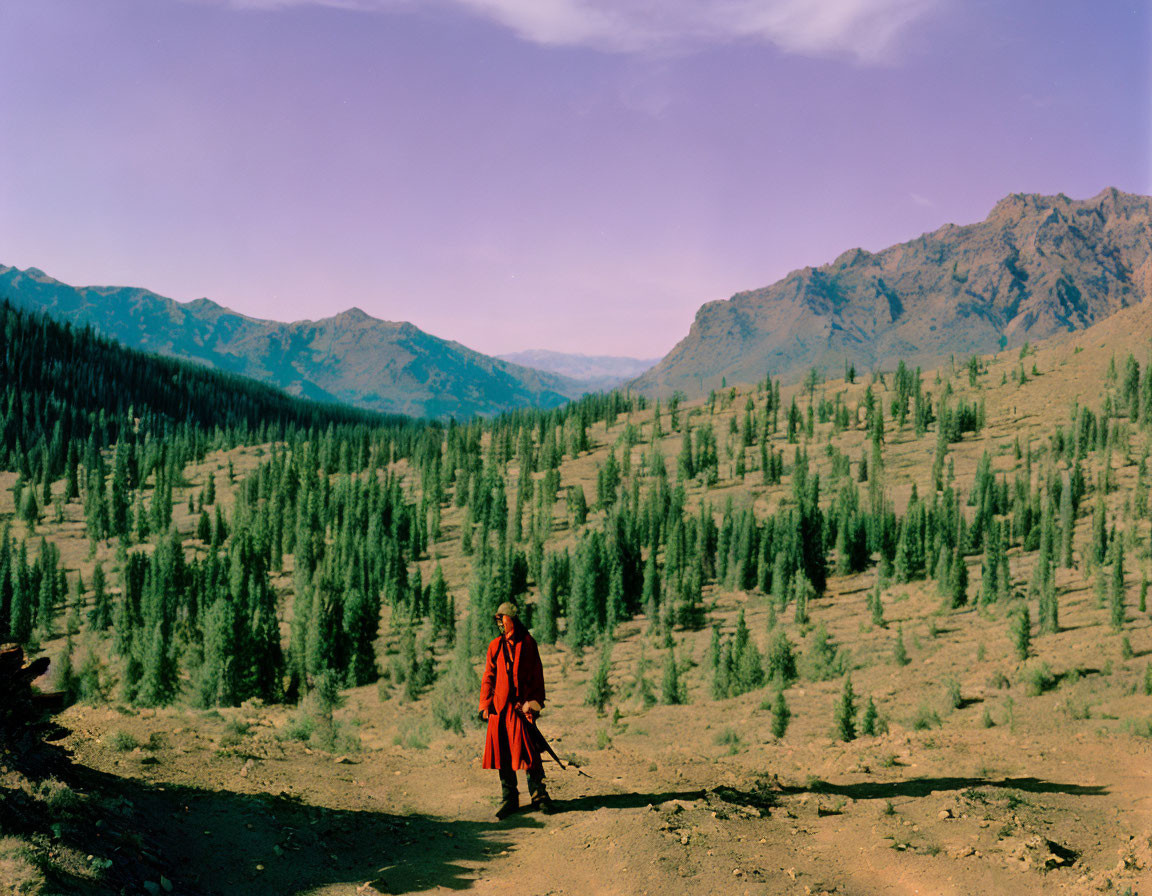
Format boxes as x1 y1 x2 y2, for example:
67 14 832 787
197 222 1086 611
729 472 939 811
632 189 1152 394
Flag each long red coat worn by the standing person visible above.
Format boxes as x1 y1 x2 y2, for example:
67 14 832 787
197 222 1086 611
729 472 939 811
480 629 544 768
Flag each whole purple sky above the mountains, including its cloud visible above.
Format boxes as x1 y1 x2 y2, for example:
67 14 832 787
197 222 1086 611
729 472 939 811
0 0 1152 357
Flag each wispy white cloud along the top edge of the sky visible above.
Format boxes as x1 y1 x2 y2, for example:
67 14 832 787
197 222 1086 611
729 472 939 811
207 0 949 64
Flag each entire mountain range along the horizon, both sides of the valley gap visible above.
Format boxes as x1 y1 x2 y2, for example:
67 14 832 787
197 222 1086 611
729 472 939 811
0 189 1152 419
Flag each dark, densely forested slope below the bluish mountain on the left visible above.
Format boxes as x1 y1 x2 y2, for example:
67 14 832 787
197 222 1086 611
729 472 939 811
0 302 425 479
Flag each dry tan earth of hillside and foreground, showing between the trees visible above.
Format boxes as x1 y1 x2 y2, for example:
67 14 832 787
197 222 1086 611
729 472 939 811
0 303 1152 896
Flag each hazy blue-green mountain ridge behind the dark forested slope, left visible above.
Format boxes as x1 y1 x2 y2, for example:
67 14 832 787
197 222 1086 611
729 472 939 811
0 265 586 419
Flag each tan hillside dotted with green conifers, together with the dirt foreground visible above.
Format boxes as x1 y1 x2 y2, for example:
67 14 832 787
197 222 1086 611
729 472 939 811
0 305 1152 894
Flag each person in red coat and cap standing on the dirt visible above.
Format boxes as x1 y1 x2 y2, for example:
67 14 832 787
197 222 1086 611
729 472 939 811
480 602 553 820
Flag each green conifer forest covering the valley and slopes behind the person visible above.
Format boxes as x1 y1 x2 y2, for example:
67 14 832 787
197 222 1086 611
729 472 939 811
0 305 1152 893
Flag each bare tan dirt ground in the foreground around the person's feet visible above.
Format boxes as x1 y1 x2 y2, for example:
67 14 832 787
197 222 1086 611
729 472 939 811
60 658 1152 896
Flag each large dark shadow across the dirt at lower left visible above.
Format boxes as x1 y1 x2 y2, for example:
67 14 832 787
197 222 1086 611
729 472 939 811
47 766 541 896
